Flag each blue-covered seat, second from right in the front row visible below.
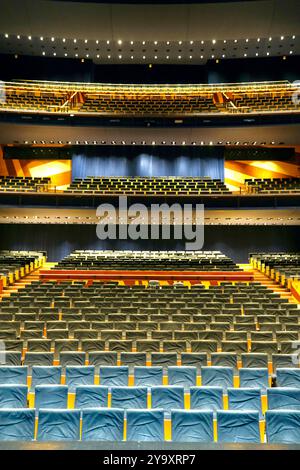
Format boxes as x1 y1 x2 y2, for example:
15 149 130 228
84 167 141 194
217 410 260 444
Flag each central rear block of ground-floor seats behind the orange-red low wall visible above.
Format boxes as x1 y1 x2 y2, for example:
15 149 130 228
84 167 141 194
53 250 241 272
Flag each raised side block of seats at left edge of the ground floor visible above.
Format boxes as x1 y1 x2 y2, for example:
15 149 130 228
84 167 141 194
0 250 46 288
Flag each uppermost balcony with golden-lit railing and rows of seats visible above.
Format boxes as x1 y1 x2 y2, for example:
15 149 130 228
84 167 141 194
0 81 300 119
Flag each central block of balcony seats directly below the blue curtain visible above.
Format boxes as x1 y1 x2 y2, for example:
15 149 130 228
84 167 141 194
65 176 231 196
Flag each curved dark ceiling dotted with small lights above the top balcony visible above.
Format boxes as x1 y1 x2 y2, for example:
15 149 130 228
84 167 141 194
0 0 300 64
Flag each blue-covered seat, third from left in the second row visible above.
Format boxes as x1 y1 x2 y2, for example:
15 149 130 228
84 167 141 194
75 385 108 409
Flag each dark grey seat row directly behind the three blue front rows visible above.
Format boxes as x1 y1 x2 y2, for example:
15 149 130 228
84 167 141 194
3 351 299 374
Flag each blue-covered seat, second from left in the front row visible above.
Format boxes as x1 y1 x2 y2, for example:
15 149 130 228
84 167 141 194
37 409 80 441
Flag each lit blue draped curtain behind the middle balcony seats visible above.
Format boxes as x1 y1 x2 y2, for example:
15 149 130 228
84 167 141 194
72 146 224 180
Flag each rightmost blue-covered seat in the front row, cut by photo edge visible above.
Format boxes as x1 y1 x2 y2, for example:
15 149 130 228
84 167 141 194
266 410 300 444
